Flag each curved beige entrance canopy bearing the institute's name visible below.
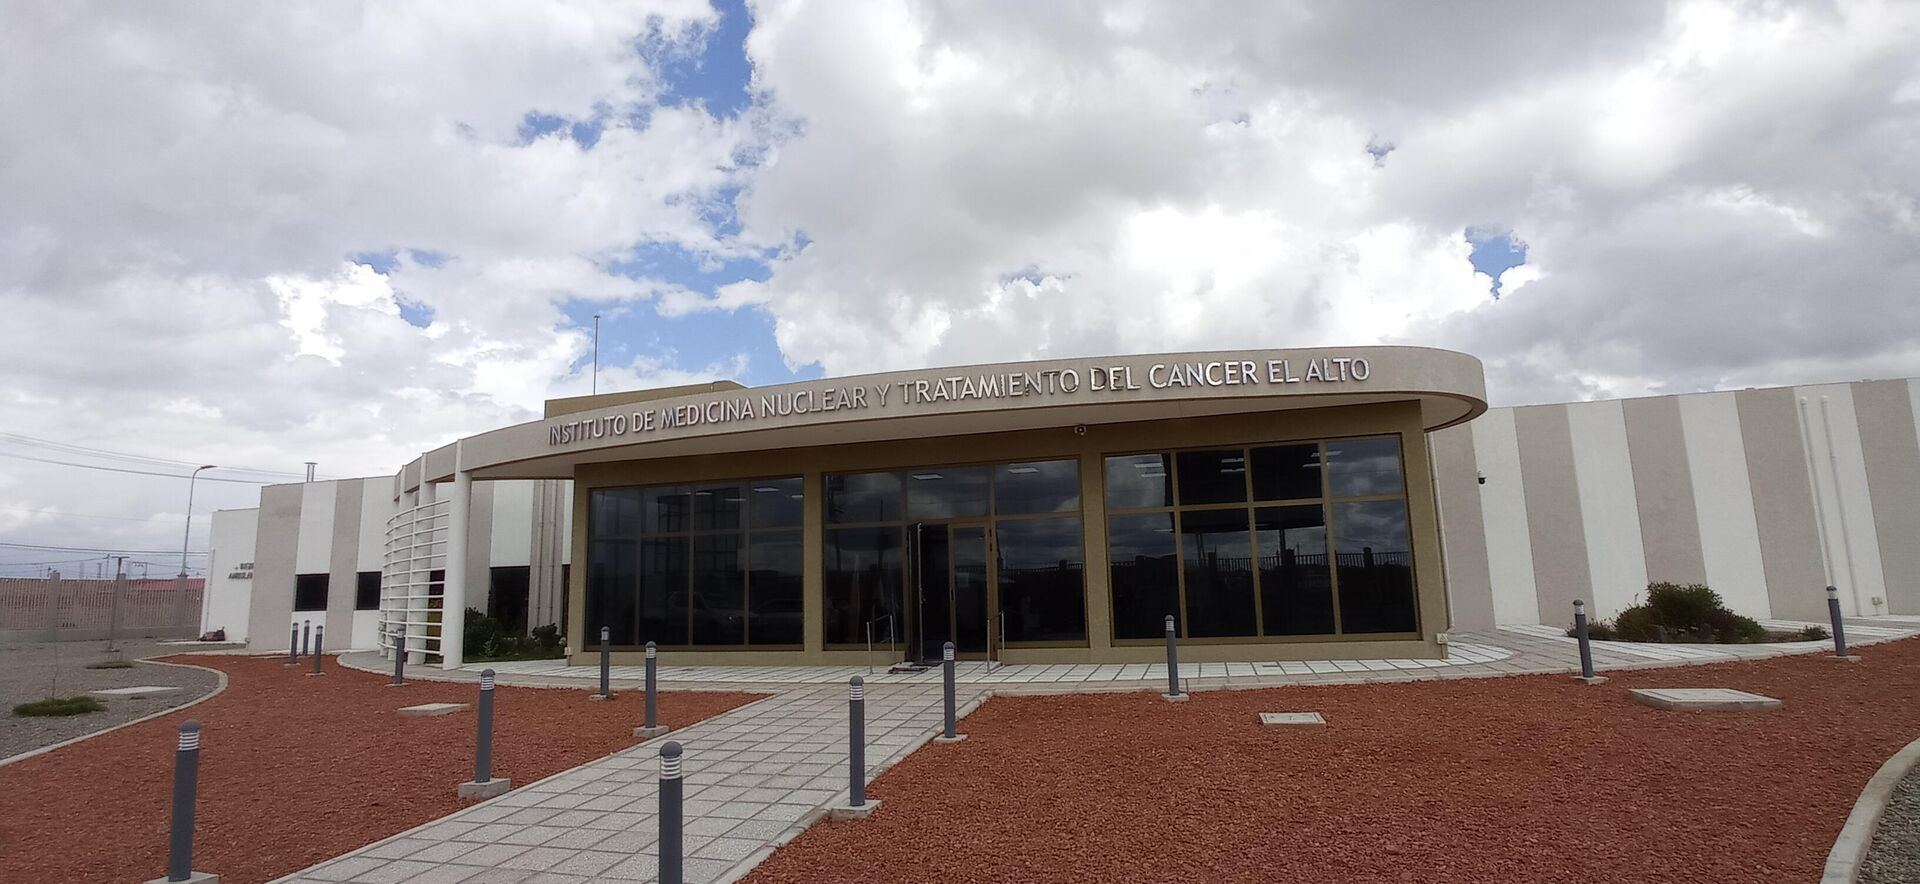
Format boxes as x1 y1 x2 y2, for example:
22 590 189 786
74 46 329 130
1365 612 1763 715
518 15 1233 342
396 346 1486 492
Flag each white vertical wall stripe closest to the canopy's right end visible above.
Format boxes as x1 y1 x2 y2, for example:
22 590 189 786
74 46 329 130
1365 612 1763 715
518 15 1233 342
1467 407 1540 625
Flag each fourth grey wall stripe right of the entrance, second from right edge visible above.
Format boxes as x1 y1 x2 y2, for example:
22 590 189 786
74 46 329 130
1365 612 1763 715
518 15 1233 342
1734 388 1826 623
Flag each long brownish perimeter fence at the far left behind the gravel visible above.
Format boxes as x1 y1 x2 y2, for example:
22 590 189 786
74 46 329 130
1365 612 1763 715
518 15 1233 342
0 575 207 642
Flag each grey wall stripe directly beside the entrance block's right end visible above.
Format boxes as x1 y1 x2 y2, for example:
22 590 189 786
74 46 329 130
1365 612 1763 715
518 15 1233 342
1427 425 1494 630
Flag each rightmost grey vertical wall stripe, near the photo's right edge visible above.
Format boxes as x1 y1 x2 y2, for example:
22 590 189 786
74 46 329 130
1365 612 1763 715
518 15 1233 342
1853 381 1920 613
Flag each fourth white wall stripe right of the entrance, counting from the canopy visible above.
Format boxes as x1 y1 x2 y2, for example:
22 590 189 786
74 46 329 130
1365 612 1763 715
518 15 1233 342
1795 384 1887 615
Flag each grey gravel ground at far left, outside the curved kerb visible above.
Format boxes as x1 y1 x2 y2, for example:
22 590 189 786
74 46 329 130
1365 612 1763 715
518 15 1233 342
0 640 238 759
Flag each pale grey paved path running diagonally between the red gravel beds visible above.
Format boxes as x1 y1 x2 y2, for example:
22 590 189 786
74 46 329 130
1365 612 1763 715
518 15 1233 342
280 684 981 884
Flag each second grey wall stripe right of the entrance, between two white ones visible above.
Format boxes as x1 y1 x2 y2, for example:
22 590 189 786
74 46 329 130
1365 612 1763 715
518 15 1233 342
1513 405 1594 623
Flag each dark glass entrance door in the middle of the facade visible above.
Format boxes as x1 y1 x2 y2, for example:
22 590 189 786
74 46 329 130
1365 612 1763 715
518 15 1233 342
912 523 993 663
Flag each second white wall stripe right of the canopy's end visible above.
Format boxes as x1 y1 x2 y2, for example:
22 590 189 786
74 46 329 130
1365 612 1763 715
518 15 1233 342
1567 400 1647 619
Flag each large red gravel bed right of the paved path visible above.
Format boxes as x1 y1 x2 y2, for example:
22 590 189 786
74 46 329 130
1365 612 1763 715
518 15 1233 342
747 640 1920 884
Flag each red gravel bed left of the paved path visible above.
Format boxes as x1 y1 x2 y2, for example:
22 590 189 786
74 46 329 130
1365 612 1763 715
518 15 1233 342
0 657 756 884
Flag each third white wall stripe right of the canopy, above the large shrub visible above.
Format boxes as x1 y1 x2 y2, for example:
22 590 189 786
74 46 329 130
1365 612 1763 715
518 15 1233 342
1680 392 1772 617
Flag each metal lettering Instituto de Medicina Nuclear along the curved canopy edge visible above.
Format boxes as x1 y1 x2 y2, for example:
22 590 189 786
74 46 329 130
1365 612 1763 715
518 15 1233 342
547 356 1373 448
